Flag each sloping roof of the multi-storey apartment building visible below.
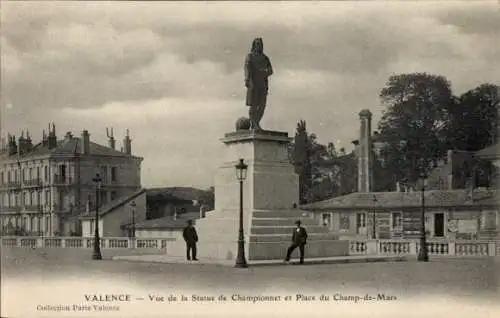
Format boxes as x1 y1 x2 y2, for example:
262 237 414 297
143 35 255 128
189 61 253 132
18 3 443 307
0 137 139 159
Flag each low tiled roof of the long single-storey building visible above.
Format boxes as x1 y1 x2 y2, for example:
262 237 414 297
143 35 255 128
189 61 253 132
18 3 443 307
301 190 498 210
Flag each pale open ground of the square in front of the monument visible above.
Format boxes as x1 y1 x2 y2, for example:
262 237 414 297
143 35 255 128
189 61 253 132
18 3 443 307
2 249 500 299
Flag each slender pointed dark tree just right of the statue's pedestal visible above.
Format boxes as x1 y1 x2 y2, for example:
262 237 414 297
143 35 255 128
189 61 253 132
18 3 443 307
292 120 311 204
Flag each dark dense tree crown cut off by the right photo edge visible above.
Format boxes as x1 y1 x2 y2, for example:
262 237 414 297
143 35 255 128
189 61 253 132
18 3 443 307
448 84 499 151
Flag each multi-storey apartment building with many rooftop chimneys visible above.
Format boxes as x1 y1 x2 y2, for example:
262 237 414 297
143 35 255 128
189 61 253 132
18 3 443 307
0 124 143 236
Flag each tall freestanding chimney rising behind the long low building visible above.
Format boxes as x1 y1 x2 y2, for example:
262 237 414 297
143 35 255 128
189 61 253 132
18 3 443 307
357 109 373 192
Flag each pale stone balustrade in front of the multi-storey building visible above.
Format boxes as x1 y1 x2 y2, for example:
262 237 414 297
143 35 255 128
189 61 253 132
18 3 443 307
1 236 173 249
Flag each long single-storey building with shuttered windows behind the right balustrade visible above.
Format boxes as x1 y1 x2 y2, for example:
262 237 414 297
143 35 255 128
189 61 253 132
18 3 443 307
302 189 500 240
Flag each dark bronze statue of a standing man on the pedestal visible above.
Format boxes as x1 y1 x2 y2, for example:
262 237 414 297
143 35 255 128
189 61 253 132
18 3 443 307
245 38 273 129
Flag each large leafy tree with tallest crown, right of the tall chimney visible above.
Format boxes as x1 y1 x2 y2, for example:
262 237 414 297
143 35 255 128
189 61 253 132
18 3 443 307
379 73 454 182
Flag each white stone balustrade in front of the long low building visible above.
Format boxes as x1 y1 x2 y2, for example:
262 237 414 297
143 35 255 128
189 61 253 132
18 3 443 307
349 239 500 257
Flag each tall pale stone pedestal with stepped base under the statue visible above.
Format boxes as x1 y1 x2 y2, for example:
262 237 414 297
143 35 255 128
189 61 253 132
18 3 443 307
167 130 348 261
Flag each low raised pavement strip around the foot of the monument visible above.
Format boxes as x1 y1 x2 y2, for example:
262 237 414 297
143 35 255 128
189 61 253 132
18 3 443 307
113 255 407 266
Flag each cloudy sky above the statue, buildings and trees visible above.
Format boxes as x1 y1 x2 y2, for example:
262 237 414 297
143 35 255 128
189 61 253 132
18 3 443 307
0 1 500 187
